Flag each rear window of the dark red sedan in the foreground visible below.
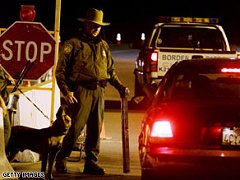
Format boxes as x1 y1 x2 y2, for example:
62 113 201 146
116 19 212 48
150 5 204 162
168 73 240 99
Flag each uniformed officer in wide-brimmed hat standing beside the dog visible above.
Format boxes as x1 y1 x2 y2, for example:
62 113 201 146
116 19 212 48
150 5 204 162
55 8 129 175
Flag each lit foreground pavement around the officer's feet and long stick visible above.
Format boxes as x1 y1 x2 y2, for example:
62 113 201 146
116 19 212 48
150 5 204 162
8 110 143 180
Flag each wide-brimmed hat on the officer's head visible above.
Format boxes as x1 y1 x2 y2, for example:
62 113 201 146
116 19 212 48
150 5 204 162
77 8 110 26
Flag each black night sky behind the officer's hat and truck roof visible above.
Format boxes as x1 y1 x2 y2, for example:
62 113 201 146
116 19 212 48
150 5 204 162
0 0 240 45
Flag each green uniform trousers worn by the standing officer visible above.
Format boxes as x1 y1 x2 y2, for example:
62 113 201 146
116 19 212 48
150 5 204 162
56 86 105 161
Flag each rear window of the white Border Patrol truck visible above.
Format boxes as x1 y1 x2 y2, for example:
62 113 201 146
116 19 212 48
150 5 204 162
154 25 225 50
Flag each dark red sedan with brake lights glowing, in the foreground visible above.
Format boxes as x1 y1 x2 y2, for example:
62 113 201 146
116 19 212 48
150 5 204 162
139 59 240 179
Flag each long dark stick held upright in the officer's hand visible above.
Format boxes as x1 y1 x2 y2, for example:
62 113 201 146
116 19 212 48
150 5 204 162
121 89 130 173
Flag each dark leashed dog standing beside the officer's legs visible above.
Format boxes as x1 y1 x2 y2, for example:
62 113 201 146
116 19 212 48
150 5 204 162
6 108 71 179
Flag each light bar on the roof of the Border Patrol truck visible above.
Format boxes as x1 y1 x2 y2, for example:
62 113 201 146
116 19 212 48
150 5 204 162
157 16 219 24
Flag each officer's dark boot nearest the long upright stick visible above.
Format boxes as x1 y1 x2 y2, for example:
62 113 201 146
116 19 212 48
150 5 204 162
83 161 105 175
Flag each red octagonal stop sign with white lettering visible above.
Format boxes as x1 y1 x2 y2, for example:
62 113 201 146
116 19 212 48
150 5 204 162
0 21 56 80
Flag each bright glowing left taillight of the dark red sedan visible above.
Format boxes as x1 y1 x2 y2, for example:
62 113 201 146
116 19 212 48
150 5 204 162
151 121 173 138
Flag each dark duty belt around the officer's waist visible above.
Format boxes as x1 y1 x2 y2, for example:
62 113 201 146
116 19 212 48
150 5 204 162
78 80 107 90
